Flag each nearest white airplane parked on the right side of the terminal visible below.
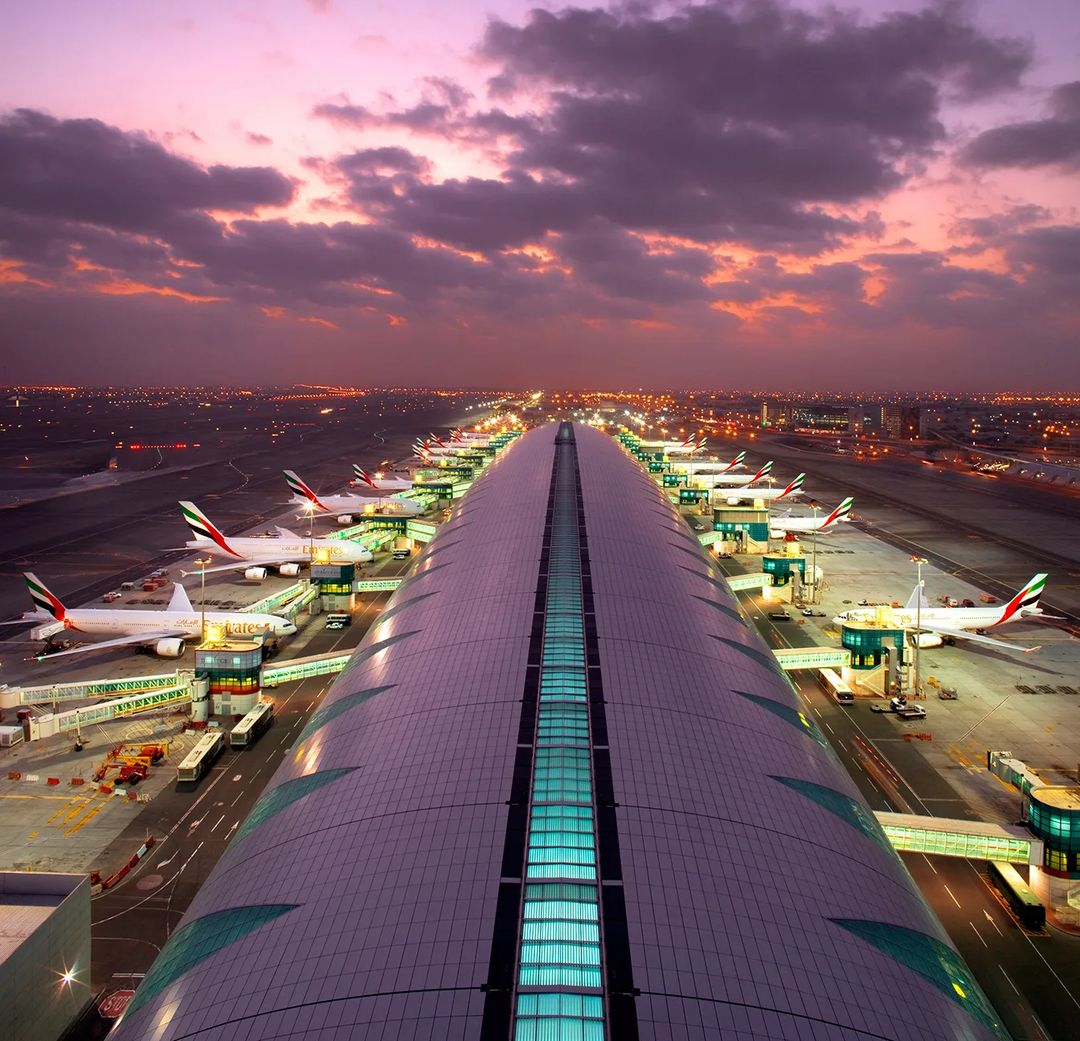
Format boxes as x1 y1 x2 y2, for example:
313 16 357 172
833 574 1053 654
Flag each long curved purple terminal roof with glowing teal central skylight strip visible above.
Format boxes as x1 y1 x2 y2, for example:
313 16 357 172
114 424 1005 1041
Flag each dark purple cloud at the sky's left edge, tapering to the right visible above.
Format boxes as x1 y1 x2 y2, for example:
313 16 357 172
0 109 294 230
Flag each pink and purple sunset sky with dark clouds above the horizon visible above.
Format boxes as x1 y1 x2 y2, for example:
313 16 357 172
0 0 1080 392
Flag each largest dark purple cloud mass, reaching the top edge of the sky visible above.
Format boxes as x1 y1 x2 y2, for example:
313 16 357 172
334 2 1028 254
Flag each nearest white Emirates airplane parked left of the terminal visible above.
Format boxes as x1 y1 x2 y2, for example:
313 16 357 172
14 572 296 660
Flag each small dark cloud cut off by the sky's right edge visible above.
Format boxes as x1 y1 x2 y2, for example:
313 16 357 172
962 81 1080 167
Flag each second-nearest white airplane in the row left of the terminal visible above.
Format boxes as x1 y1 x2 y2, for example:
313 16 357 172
180 502 373 582
